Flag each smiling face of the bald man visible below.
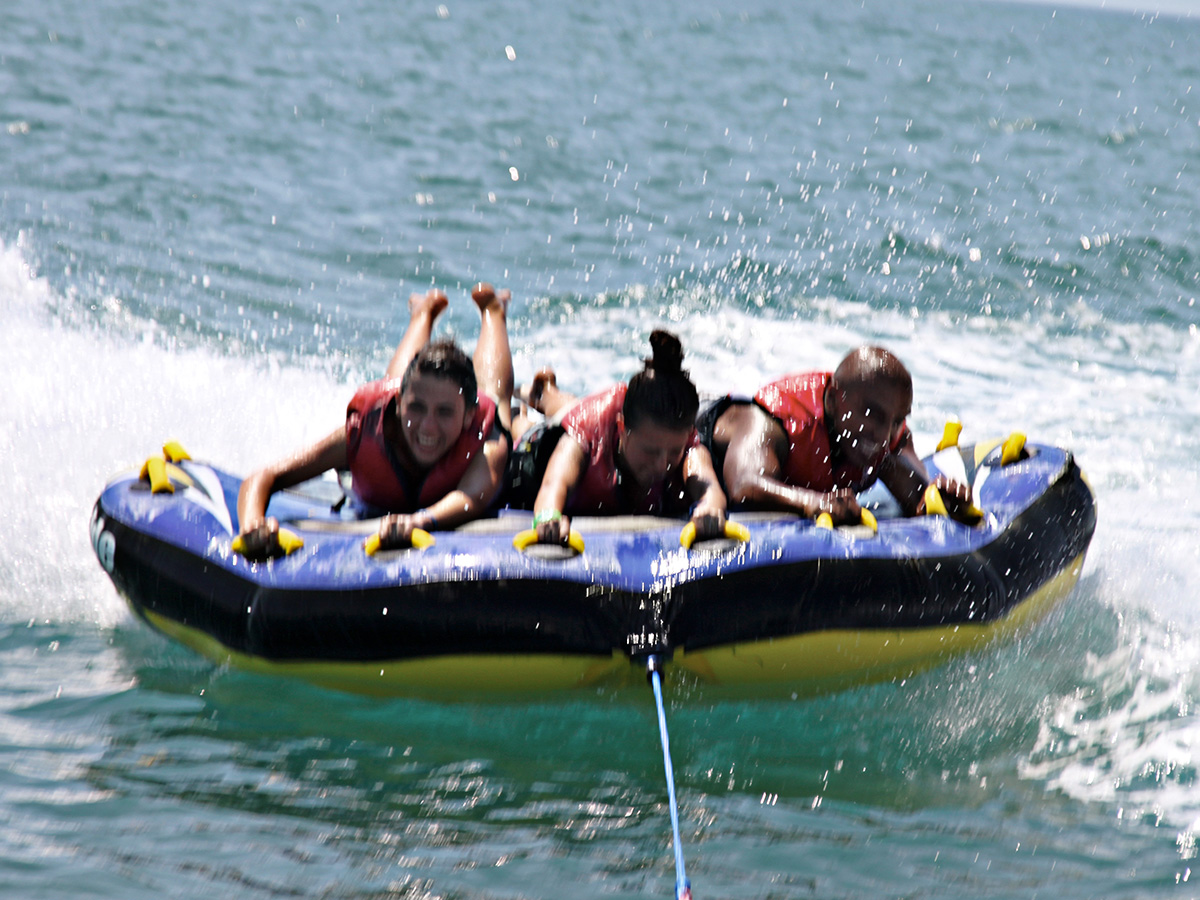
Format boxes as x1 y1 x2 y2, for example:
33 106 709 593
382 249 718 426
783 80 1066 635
828 384 912 472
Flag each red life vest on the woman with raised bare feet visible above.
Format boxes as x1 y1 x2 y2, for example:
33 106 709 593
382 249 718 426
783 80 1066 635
346 378 496 512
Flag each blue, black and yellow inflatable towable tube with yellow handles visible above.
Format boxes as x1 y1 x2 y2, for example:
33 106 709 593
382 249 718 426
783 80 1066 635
91 436 1096 694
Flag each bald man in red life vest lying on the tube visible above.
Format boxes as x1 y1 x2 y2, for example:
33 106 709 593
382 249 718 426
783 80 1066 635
697 347 971 524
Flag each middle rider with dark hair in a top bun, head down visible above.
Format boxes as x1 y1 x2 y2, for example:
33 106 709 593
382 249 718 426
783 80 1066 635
510 330 726 544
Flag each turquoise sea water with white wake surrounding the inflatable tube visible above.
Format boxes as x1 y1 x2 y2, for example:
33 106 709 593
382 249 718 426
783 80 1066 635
0 0 1200 900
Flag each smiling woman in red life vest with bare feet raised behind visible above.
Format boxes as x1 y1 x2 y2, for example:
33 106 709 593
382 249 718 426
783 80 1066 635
238 284 512 559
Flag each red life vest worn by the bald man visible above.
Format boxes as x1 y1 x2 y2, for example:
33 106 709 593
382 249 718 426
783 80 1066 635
754 372 908 493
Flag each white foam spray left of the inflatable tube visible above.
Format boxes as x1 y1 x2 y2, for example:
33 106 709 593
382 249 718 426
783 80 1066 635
0 244 348 624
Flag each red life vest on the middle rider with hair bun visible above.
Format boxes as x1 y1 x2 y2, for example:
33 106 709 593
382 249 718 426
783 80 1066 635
563 384 700 516
